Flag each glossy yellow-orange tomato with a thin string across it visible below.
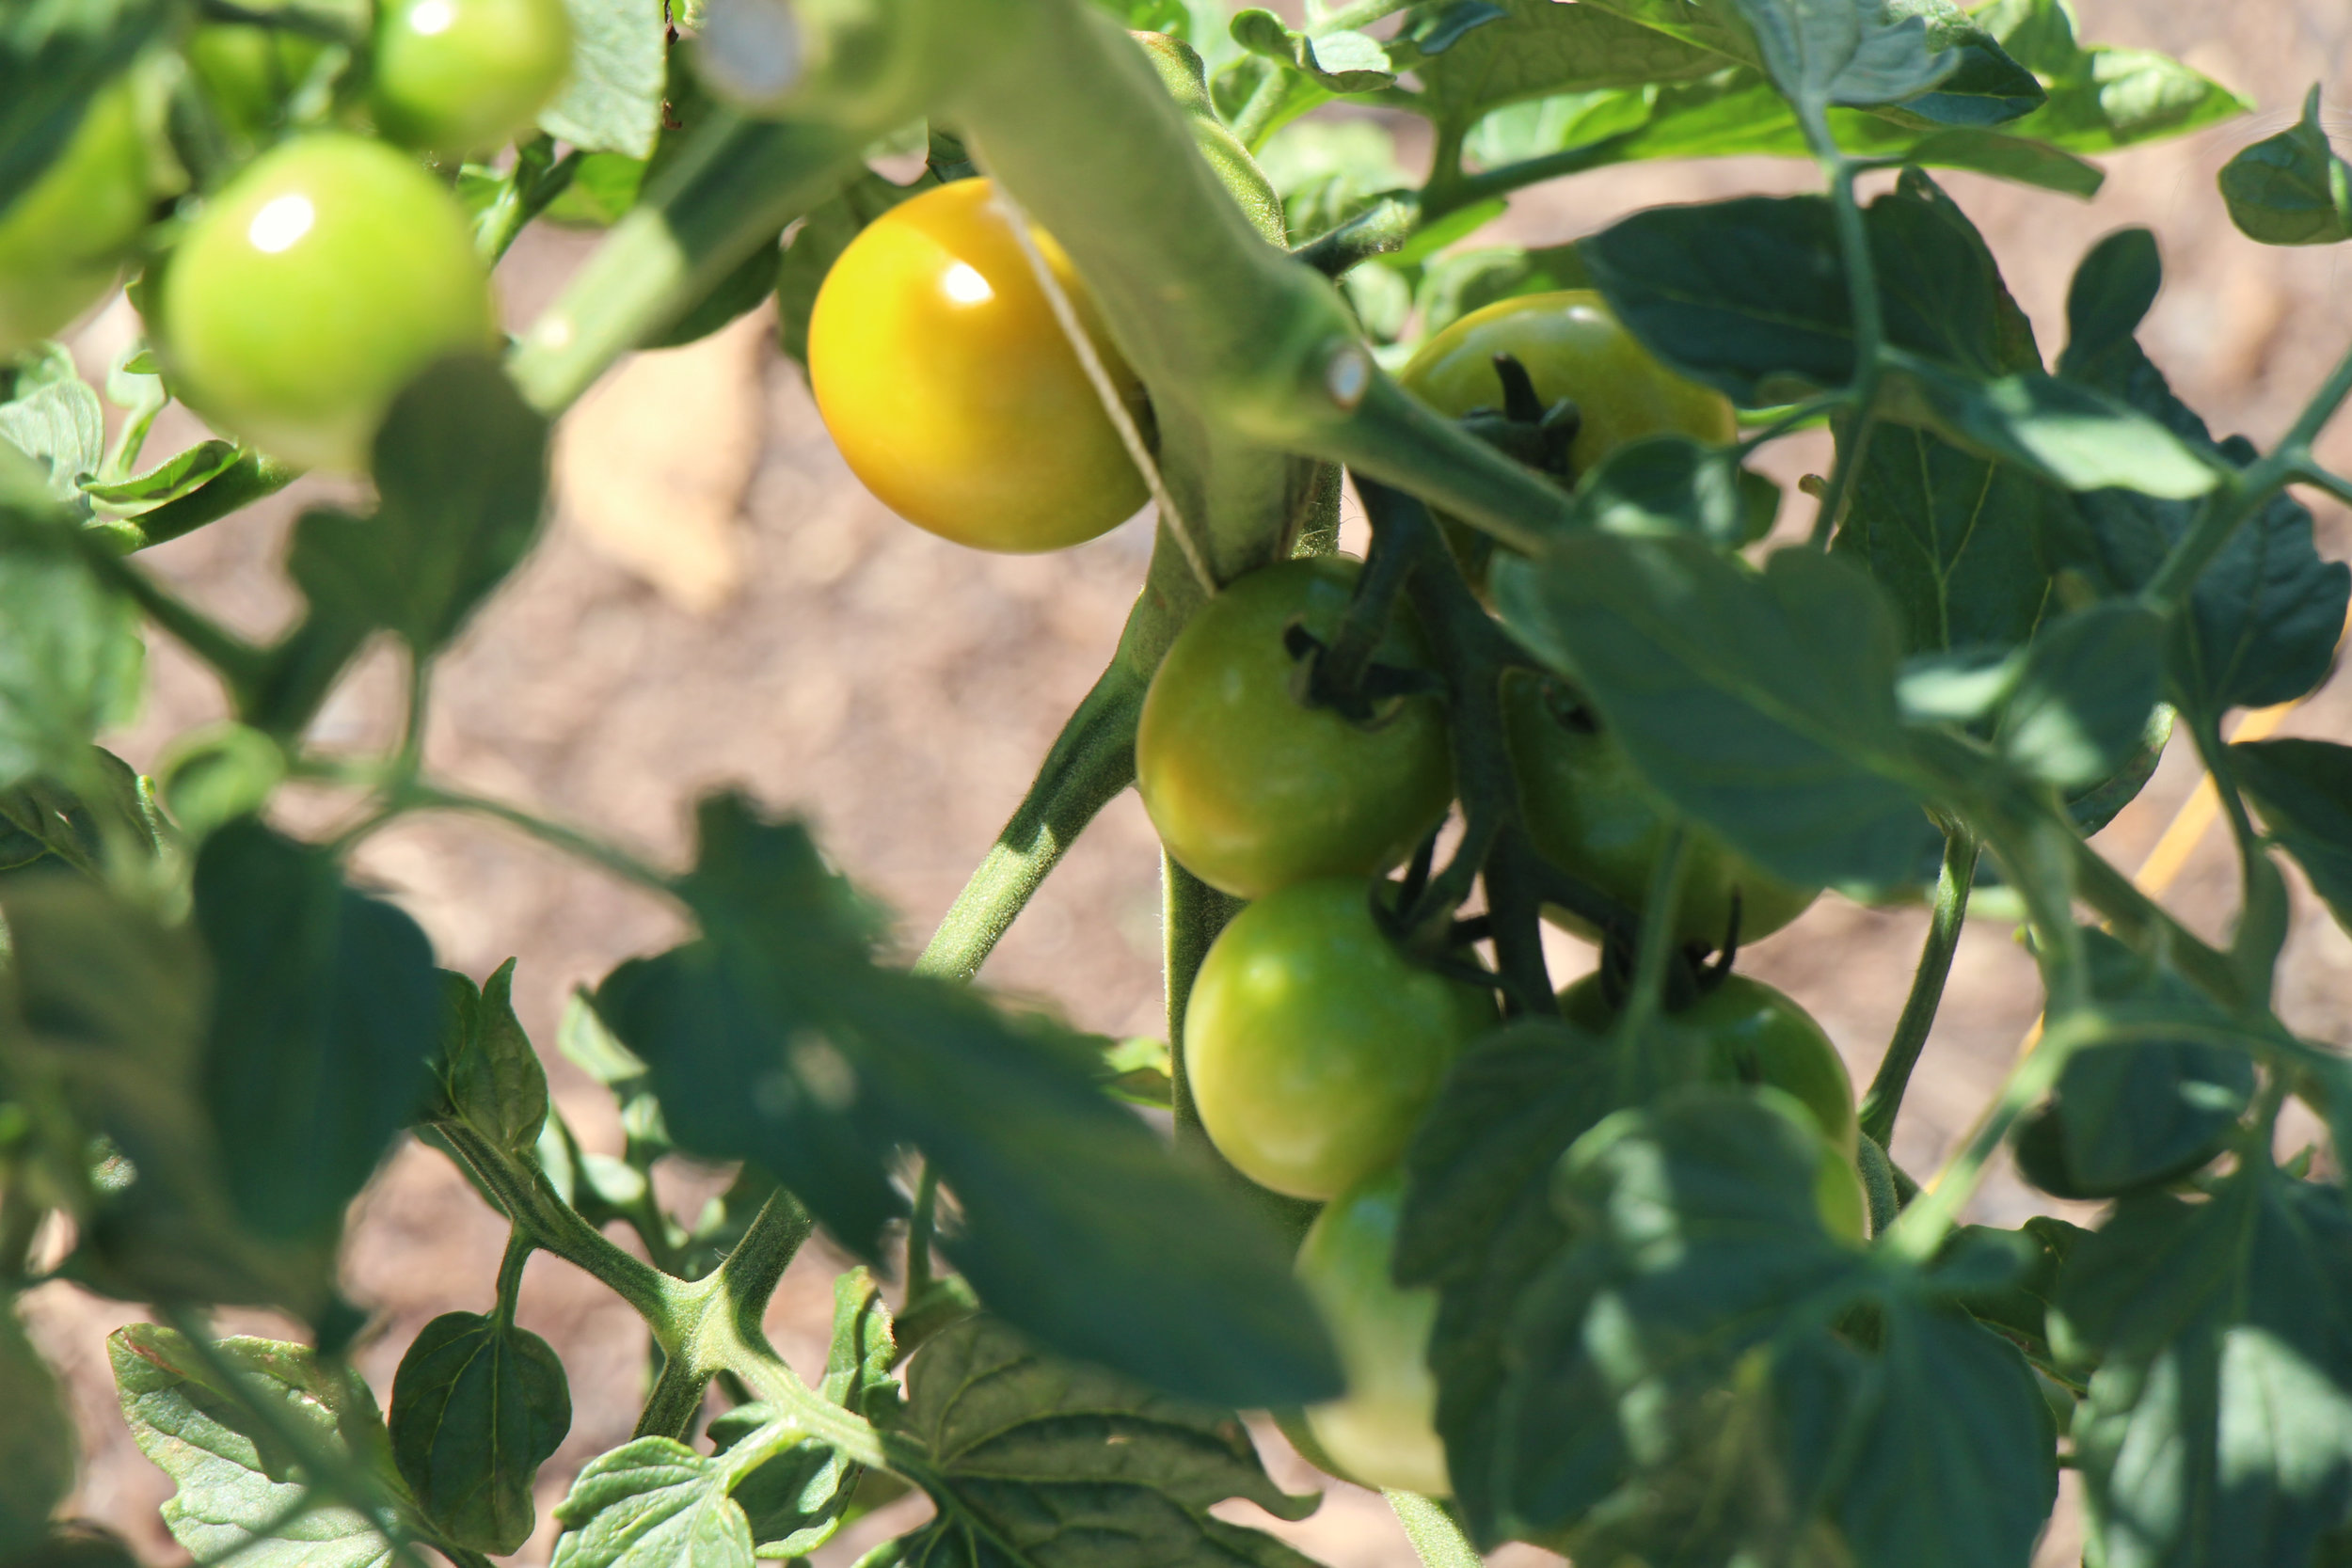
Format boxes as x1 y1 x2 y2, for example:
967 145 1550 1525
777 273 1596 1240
809 179 1146 552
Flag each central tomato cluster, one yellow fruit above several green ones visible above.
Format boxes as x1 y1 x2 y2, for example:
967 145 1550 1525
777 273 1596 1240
809 179 1866 1496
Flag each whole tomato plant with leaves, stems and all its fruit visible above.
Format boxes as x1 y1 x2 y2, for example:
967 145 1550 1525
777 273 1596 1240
0 0 2352 1568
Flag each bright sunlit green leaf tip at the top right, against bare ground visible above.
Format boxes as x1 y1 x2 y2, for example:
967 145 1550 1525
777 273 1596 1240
1976 0 2249 152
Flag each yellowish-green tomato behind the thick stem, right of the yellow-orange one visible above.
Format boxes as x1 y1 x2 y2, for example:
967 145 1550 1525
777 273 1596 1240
1397 289 1739 472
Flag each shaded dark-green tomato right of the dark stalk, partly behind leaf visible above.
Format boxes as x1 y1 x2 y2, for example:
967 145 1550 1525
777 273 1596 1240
1505 679 1820 947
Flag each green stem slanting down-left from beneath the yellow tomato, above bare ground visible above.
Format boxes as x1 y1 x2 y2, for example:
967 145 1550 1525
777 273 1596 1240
915 658 1146 980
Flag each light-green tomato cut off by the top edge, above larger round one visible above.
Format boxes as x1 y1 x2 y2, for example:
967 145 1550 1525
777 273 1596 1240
370 0 572 157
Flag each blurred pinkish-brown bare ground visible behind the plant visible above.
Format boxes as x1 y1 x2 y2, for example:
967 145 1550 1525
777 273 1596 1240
26 0 2352 1568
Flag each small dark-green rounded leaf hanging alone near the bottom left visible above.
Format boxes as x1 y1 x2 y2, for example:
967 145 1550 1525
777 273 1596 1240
390 1307 572 1552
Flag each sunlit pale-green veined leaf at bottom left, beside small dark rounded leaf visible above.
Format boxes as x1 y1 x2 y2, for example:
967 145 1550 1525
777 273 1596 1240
106 1323 407 1568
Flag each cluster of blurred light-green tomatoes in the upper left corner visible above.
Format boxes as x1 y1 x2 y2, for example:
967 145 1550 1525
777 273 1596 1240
0 0 572 470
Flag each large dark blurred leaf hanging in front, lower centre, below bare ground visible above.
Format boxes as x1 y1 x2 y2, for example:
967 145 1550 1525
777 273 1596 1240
596 797 1339 1406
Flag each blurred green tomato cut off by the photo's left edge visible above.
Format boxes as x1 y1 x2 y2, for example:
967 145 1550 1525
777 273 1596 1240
0 77 151 359
